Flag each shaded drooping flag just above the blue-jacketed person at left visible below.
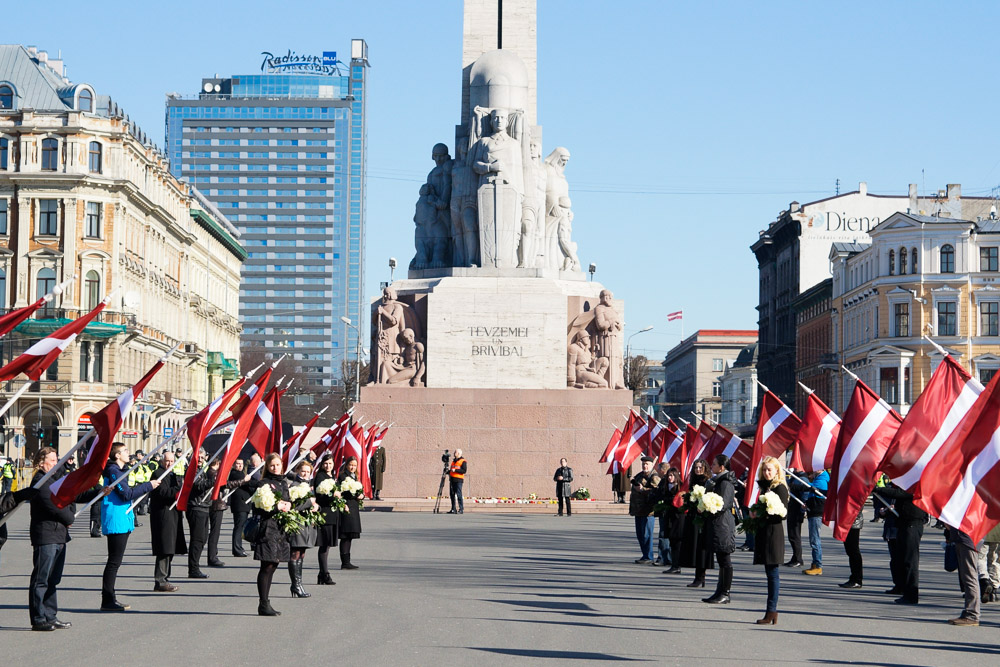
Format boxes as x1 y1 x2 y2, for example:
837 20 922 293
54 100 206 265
50 360 166 509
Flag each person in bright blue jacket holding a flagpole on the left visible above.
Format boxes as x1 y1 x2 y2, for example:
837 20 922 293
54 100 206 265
101 442 160 611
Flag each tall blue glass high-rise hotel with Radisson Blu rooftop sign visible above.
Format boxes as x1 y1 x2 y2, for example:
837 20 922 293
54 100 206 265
166 39 368 393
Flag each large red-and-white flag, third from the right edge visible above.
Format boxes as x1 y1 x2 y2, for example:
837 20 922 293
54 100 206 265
823 380 903 542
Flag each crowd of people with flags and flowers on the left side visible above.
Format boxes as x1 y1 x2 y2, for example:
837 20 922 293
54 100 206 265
0 443 372 631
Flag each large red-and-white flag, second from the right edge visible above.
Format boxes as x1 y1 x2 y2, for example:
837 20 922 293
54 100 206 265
879 356 983 490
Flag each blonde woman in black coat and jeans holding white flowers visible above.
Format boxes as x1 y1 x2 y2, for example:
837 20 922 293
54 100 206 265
750 456 788 625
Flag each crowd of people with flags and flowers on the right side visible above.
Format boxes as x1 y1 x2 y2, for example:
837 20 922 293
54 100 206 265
613 455 1000 626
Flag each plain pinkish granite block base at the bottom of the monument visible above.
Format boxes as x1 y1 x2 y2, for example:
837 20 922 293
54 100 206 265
354 385 632 500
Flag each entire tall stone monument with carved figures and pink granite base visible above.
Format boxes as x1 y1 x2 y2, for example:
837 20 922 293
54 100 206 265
358 0 632 498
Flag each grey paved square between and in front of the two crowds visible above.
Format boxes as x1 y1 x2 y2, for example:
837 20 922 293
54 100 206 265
0 511 1000 665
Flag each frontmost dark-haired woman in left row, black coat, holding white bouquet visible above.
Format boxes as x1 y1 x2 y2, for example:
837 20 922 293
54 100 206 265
253 453 292 616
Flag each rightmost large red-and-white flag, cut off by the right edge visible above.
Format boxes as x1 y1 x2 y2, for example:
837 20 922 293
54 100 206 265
914 373 1000 544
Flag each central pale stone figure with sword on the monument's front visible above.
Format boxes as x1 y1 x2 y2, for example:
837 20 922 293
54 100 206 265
468 107 524 267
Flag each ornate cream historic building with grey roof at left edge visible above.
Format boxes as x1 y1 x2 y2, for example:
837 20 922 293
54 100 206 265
0 45 246 456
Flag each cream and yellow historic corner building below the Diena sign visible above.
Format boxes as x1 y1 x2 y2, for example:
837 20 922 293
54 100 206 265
830 209 1000 415
